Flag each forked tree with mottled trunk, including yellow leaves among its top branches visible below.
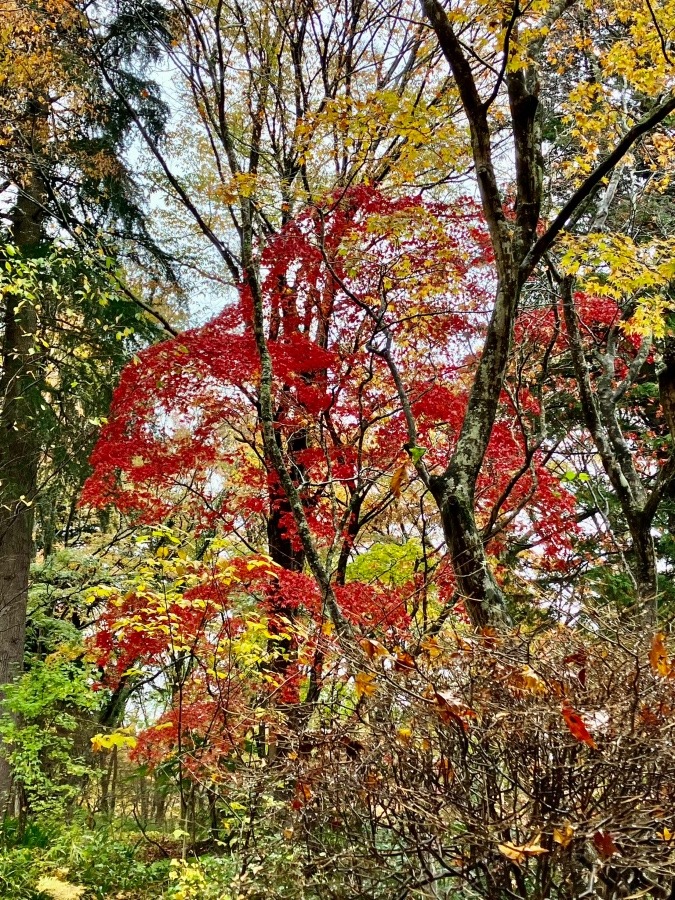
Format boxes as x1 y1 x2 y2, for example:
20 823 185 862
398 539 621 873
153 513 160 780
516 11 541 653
418 0 675 623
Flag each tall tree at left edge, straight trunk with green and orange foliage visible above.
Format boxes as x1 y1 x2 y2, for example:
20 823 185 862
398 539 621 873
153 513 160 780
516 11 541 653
0 0 177 795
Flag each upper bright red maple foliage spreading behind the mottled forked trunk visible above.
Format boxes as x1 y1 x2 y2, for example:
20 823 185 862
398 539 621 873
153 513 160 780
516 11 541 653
83 186 572 564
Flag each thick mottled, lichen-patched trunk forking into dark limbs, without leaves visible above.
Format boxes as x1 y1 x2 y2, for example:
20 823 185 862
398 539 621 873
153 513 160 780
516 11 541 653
420 0 675 625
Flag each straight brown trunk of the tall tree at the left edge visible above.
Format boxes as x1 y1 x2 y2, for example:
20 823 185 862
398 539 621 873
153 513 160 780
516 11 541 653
0 171 45 800
